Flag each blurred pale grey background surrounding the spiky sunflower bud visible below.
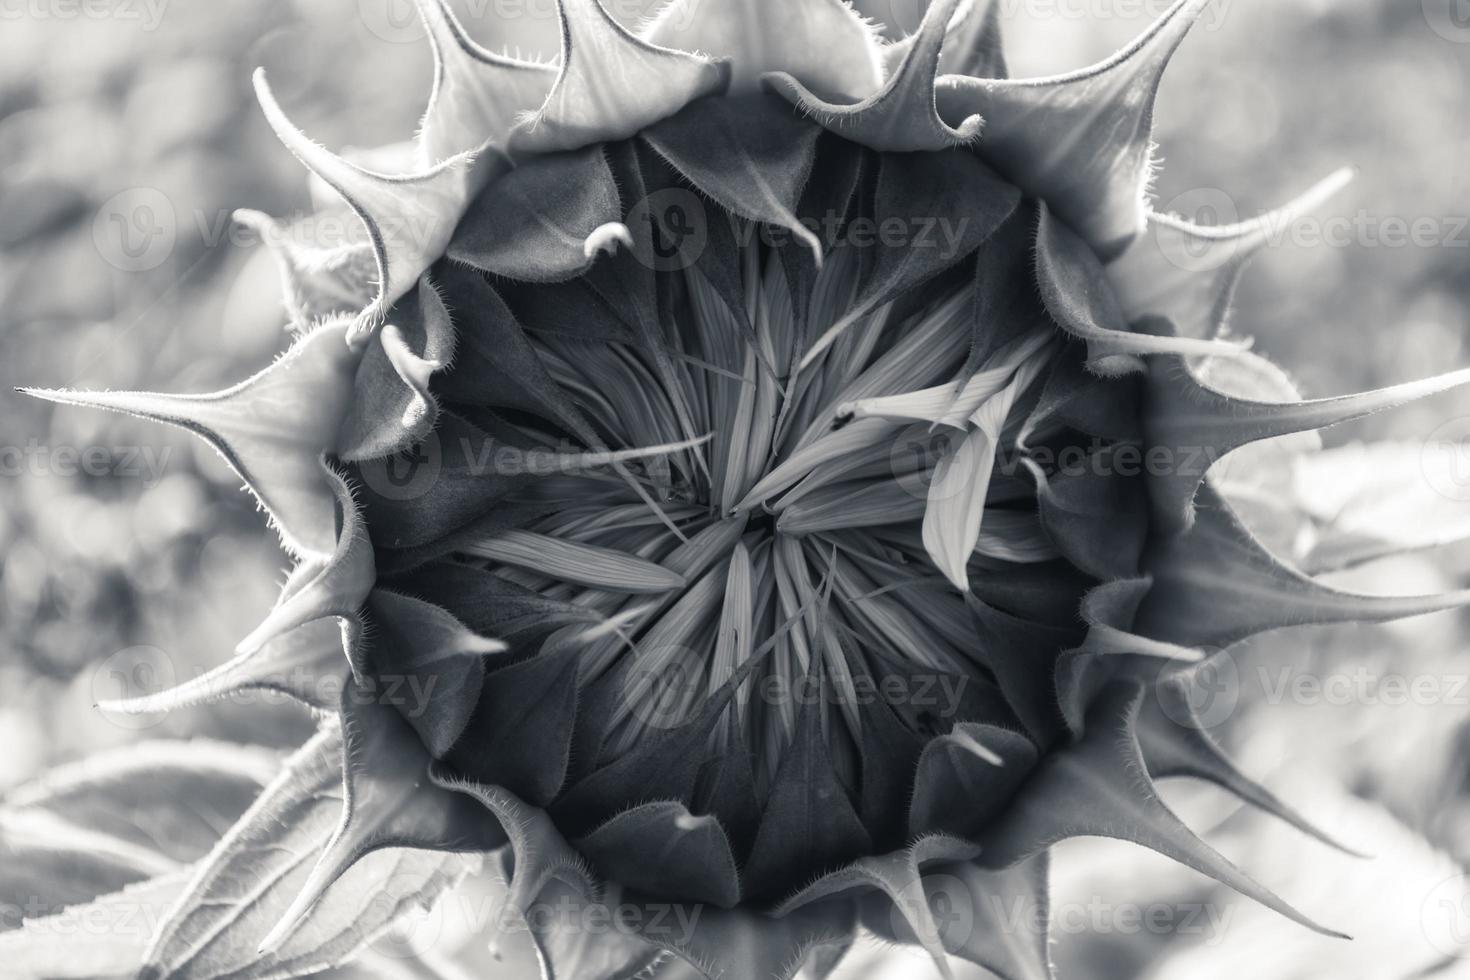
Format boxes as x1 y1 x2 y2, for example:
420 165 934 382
0 0 1470 980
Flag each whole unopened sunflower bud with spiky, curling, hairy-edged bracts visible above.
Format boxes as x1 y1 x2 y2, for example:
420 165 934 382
11 0 1467 980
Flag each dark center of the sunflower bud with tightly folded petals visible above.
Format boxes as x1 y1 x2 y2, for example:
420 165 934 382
366 126 1123 898
